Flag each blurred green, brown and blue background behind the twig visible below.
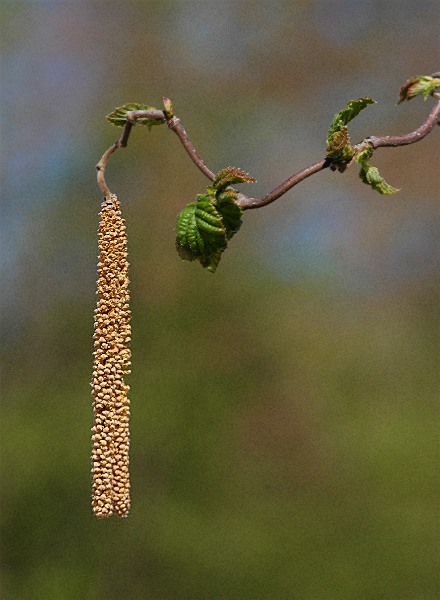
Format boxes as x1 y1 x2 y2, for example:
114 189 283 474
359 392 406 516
0 0 440 600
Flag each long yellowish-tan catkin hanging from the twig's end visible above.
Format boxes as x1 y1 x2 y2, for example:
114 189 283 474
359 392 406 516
91 194 131 518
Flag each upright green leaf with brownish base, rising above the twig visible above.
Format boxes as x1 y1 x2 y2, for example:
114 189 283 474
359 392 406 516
326 98 375 162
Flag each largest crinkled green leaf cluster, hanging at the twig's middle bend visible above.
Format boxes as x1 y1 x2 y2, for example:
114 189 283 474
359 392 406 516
176 167 255 273
